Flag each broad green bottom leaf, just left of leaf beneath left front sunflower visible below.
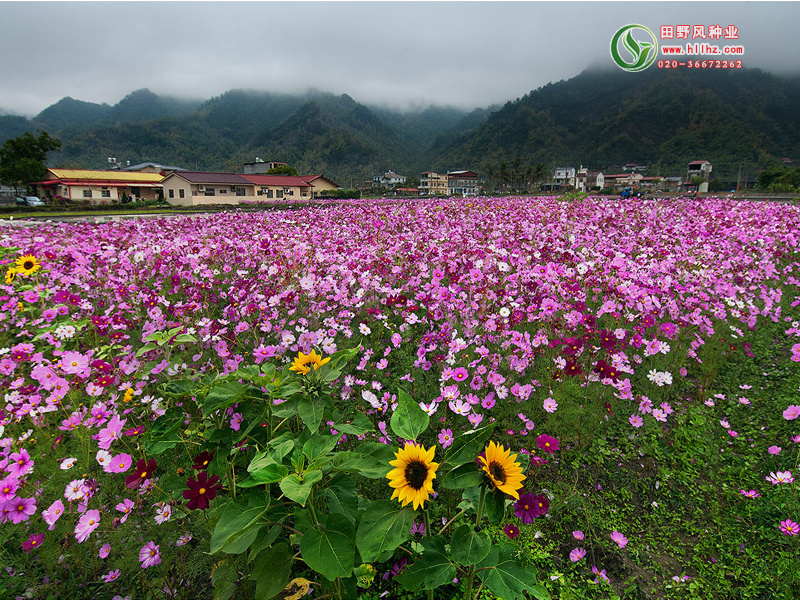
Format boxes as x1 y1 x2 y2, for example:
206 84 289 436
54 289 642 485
300 514 356 581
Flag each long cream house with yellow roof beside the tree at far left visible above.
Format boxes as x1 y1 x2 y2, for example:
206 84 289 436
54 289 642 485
34 169 162 204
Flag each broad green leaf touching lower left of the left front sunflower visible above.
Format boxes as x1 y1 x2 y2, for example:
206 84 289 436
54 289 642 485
356 500 416 563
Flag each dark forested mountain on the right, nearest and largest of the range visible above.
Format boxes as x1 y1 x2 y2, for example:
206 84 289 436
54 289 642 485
432 69 800 179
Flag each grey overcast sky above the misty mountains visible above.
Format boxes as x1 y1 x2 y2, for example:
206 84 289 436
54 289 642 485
0 1 800 116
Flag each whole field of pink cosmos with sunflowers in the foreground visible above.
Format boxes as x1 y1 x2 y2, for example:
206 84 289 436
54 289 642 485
0 197 800 600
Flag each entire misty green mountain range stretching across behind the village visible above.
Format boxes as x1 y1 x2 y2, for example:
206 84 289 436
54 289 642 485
0 67 800 186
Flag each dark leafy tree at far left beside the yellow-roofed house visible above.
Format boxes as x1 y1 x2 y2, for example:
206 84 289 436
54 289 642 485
0 130 61 193
